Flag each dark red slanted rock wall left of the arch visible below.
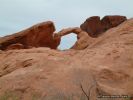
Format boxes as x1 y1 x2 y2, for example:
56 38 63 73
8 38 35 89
0 21 59 50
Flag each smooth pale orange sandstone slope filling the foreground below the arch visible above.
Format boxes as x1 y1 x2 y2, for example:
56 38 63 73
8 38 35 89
0 16 133 100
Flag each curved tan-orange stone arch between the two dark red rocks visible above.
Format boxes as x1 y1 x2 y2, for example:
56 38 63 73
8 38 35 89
54 27 90 50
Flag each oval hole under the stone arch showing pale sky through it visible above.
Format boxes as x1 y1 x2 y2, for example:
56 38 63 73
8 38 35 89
58 33 77 50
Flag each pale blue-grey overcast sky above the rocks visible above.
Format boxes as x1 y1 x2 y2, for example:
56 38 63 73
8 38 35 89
0 0 133 49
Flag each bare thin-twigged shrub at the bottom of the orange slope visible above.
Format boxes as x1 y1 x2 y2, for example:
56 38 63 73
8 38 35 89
72 68 98 100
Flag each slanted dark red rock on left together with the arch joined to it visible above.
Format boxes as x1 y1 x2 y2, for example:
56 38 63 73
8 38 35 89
0 21 90 50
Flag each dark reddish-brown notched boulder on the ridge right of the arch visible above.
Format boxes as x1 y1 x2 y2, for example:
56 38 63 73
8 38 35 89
80 16 127 37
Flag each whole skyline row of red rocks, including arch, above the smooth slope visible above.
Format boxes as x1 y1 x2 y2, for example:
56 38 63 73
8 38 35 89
0 16 126 50
